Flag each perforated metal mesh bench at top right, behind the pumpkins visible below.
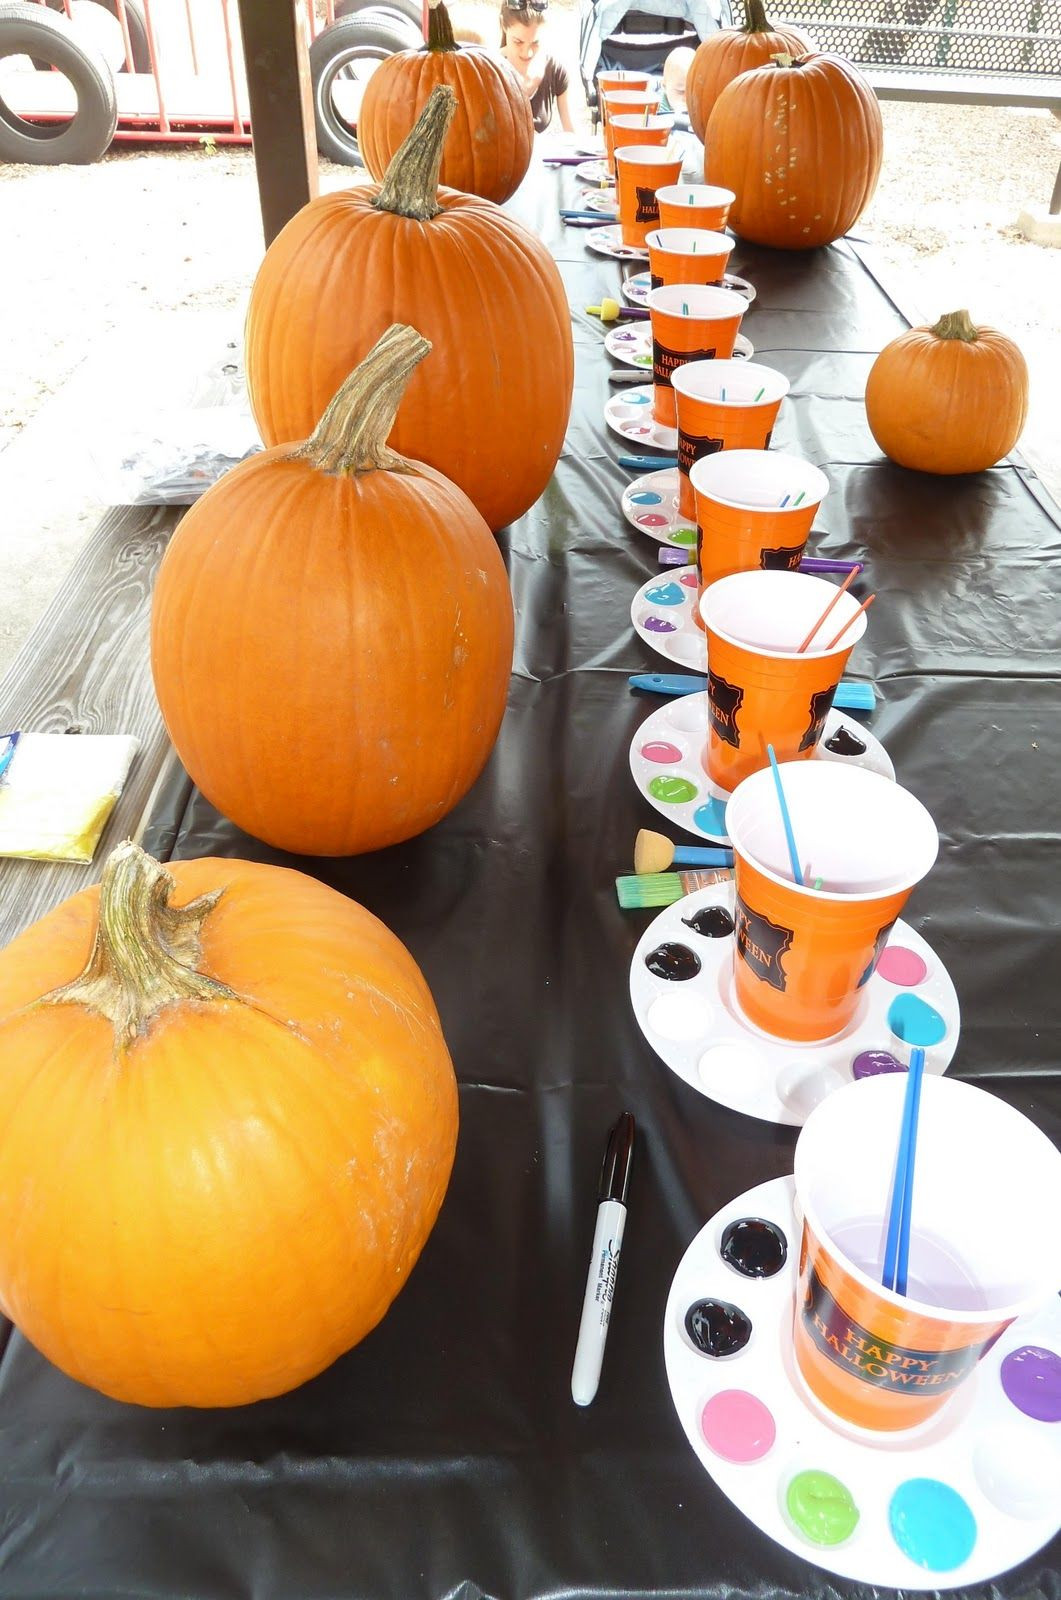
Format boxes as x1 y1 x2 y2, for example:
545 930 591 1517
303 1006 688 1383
779 0 1061 214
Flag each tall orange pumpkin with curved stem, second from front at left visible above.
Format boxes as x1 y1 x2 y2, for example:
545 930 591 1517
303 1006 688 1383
150 318 512 856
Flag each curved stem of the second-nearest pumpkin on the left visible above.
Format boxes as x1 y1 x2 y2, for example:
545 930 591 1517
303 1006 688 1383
294 322 430 472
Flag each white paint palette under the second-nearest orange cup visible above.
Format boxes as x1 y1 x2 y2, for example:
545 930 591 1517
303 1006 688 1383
631 882 960 1126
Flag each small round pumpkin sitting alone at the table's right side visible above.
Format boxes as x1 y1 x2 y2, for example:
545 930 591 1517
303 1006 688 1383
866 310 1027 477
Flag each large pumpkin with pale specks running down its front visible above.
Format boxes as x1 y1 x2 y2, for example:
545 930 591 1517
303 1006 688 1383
704 54 883 250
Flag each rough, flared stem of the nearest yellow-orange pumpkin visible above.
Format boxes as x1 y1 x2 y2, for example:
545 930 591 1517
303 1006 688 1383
38 838 237 1051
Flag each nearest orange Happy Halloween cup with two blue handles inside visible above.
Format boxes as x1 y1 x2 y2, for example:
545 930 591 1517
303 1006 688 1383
792 1072 1061 1434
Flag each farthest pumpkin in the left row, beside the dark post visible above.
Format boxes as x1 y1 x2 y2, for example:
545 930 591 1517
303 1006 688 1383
357 0 535 205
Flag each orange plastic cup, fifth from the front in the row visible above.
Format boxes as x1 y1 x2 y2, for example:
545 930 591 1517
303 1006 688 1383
672 360 789 520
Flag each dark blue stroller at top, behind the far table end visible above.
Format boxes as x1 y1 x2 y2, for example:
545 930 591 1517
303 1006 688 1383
579 0 731 112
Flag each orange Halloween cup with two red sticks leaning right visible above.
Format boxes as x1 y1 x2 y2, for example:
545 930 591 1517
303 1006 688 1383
699 571 866 789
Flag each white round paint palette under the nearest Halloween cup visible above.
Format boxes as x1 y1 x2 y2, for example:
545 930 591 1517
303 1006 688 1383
663 1178 1061 1590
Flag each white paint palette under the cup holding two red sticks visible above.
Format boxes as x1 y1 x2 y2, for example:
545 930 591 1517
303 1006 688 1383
631 697 895 845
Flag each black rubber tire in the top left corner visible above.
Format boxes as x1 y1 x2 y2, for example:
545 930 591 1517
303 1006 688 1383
0 0 118 166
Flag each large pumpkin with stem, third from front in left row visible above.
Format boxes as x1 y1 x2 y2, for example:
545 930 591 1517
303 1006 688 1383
246 86 575 530
